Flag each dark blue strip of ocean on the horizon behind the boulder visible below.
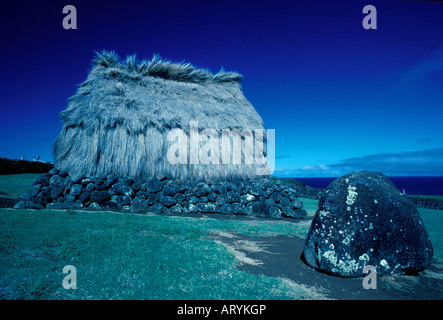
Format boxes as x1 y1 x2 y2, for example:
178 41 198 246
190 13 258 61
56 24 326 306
294 177 443 195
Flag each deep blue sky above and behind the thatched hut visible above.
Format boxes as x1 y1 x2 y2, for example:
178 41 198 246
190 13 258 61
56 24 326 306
0 0 443 177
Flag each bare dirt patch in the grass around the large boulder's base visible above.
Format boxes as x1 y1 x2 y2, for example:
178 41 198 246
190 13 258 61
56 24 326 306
211 232 443 300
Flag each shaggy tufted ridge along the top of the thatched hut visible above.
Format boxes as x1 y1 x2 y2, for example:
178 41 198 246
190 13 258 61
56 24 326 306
93 51 243 83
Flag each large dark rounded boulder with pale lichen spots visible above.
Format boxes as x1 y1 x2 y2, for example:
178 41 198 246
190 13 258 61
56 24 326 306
303 171 433 277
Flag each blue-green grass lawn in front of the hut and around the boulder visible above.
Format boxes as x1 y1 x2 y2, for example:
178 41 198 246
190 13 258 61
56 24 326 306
0 175 443 300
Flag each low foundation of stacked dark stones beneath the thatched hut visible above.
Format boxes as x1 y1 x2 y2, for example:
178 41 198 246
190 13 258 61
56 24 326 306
14 168 307 219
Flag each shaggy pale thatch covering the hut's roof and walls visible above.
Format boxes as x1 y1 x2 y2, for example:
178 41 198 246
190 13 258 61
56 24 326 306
54 52 264 180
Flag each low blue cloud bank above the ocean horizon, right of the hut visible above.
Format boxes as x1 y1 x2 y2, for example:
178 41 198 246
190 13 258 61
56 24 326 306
276 148 443 177
